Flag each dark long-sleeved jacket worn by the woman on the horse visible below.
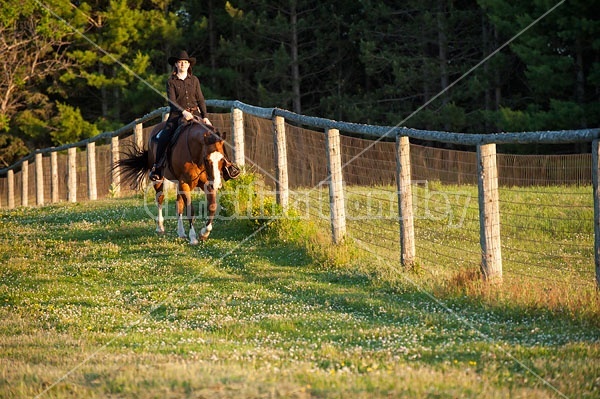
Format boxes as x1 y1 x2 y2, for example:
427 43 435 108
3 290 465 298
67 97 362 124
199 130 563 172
167 72 206 118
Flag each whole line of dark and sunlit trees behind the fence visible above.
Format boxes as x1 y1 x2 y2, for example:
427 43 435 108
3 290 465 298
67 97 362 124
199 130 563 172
0 0 600 166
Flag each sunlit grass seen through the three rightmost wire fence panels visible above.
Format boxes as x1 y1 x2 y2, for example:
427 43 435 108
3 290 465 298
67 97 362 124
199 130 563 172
318 182 598 314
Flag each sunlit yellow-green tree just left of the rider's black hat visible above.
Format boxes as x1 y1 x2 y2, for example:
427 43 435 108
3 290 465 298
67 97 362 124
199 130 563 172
63 0 180 123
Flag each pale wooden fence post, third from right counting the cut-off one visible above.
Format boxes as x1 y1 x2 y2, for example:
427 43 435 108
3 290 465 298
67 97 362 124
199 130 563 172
396 135 415 268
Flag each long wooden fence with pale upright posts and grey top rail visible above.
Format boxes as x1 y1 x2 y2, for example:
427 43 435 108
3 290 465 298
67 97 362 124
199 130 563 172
0 100 600 287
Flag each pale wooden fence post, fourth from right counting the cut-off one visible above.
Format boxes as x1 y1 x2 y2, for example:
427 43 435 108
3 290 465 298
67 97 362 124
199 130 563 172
325 129 346 244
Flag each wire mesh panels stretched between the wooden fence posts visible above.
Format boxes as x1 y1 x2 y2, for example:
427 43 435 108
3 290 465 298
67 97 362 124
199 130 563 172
0 103 595 289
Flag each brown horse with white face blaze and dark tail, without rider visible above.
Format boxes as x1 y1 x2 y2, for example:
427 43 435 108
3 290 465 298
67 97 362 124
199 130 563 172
113 120 239 245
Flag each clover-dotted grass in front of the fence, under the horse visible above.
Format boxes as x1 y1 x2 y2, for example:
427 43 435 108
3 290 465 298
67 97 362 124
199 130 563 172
0 180 600 399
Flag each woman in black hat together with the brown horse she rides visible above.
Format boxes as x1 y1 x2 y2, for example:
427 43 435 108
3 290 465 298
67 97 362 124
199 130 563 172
113 51 240 244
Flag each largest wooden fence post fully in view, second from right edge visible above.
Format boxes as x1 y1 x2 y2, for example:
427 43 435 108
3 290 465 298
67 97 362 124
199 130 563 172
477 143 502 283
